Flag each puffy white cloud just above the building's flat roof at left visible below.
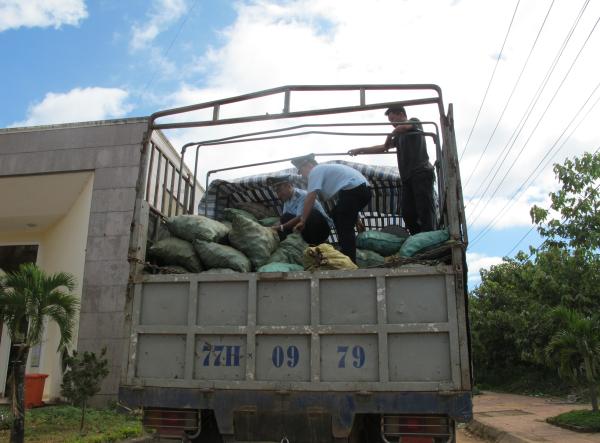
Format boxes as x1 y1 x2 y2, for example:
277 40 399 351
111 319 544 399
11 87 131 127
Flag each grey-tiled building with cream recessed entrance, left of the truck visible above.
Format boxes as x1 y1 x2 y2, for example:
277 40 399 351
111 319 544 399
0 118 203 402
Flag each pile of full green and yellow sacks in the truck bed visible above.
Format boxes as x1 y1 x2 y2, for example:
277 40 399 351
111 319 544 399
147 208 448 273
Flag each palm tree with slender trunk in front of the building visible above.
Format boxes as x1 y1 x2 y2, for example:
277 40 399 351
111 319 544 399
0 263 79 443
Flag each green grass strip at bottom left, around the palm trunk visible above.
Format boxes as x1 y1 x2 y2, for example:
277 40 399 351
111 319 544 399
0 405 143 443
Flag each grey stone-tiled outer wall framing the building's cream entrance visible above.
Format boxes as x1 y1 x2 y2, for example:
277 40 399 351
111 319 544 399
0 119 147 403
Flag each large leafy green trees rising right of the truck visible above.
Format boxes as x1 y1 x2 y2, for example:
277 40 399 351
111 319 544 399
469 152 600 383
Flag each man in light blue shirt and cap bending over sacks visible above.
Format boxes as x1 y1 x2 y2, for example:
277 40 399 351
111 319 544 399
292 154 371 263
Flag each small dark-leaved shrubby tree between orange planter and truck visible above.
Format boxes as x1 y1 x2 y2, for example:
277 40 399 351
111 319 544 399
61 348 108 432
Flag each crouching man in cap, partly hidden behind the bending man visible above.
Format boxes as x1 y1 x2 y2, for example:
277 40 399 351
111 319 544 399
267 175 333 245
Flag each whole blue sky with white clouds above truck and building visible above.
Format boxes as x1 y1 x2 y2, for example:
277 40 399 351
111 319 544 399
0 0 600 285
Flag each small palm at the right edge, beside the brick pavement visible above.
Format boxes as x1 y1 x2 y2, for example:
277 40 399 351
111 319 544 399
546 307 600 412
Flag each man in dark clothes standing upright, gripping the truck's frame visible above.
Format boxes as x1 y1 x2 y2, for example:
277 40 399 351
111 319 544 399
348 105 435 235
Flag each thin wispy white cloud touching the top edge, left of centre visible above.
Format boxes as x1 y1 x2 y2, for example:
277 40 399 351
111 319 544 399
129 0 187 50
